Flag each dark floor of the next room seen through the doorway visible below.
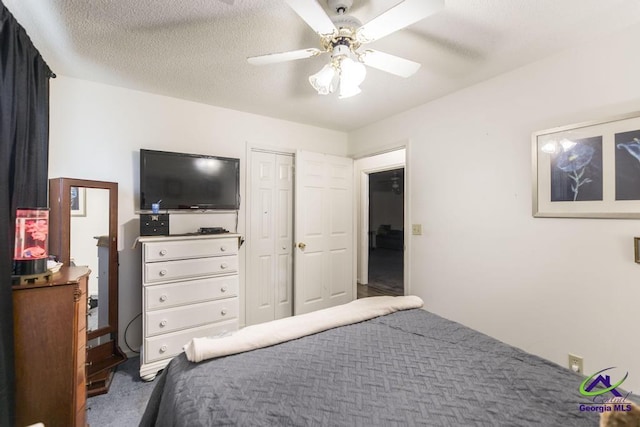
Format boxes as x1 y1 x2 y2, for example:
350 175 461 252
368 248 404 296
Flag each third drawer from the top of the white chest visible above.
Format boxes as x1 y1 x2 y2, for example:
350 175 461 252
144 275 239 310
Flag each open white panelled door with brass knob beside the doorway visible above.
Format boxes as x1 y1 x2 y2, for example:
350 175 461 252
294 151 355 314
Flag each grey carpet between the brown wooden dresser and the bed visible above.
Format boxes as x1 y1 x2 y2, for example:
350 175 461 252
87 357 155 427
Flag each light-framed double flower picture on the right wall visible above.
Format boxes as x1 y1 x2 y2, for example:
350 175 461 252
532 111 640 219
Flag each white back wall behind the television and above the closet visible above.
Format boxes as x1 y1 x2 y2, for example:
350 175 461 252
49 76 347 352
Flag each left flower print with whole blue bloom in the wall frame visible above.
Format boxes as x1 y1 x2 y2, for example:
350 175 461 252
551 136 602 202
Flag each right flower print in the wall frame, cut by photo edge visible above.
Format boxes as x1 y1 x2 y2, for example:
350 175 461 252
615 130 640 200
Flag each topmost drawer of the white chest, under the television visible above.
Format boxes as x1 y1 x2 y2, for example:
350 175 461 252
142 237 238 262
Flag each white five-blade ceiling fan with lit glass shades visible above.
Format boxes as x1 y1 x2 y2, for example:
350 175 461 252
247 0 444 98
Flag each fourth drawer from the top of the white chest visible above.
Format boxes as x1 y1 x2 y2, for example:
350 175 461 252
144 297 239 336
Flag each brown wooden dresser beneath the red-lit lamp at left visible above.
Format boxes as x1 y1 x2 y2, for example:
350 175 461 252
13 267 90 427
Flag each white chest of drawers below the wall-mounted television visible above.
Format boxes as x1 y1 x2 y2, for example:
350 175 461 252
138 234 240 381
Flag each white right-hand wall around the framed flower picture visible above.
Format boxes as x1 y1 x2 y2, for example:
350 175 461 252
349 22 640 393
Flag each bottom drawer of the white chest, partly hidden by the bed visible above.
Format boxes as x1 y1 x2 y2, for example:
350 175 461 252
144 319 238 363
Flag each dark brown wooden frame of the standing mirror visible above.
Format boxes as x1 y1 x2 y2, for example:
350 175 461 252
49 178 118 345
